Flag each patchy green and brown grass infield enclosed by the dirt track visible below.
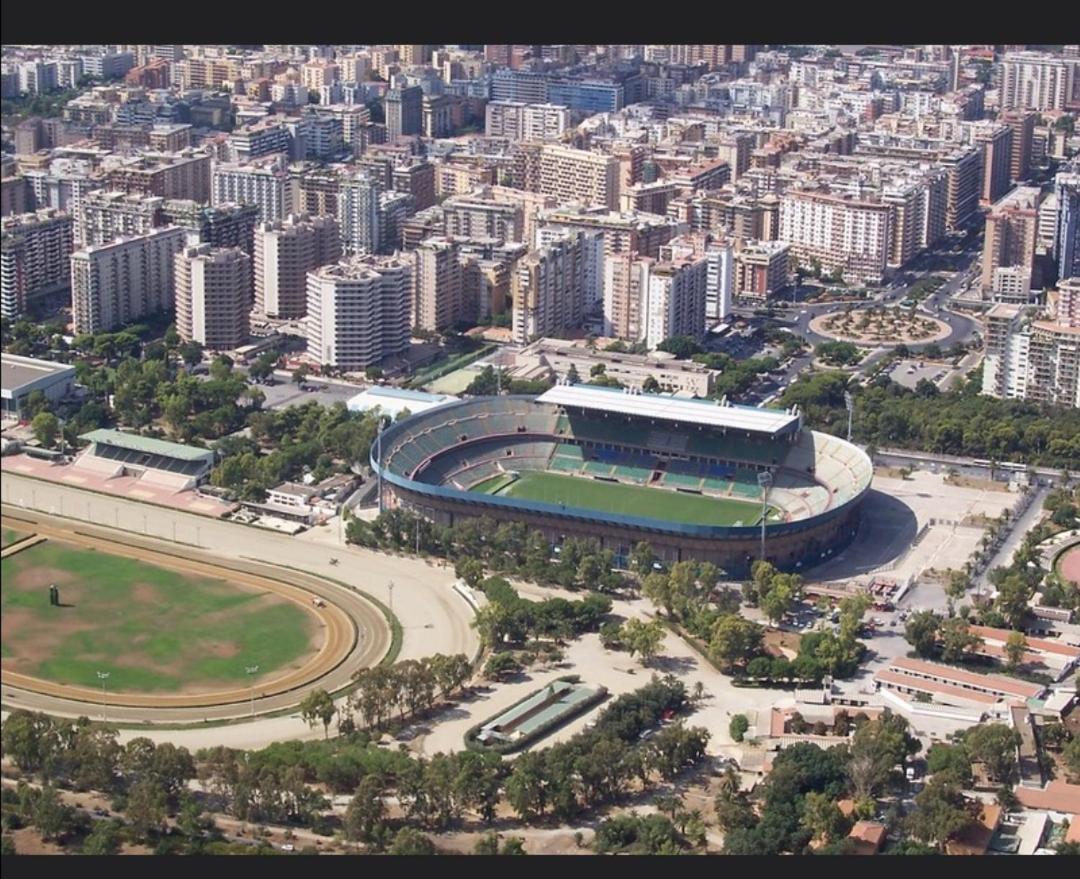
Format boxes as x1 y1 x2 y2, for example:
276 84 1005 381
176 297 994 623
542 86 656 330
0 540 319 693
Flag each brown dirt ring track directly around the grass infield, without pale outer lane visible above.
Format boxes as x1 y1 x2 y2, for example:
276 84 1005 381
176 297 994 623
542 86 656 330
2 509 391 721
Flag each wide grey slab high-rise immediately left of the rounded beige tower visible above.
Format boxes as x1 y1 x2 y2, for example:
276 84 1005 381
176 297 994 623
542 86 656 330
71 226 188 334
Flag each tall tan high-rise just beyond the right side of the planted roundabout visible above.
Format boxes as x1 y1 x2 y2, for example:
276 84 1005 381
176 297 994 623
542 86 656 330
981 187 1040 305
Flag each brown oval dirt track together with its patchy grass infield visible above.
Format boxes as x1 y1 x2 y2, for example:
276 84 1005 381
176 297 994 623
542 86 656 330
2 511 391 724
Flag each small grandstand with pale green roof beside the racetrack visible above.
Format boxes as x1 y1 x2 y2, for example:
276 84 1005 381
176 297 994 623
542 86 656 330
76 429 215 491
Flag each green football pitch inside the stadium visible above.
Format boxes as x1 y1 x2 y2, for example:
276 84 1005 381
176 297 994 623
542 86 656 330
473 470 777 525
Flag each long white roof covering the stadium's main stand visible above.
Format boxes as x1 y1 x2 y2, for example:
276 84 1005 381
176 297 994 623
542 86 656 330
537 384 799 436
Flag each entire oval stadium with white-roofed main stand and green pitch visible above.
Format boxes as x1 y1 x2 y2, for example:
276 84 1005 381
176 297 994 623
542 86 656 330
372 384 873 576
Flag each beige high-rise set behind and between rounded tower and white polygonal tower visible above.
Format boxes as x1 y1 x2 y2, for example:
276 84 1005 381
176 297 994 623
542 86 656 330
254 215 341 319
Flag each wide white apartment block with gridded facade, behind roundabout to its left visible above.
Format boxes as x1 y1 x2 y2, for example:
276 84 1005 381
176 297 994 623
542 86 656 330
779 190 891 284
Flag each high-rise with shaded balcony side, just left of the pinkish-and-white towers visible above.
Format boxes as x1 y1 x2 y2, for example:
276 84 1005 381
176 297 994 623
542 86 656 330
511 231 596 344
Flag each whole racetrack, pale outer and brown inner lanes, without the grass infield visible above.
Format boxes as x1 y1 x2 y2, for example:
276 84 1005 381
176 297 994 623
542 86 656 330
2 472 478 747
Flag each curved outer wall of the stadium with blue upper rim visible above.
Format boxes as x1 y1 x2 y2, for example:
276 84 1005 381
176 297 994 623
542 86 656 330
372 402 869 577
